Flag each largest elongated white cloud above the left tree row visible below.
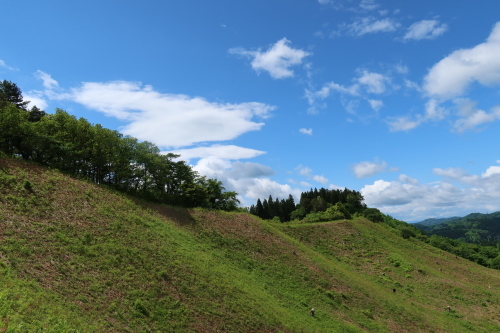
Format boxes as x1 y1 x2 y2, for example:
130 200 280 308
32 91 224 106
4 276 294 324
69 81 275 147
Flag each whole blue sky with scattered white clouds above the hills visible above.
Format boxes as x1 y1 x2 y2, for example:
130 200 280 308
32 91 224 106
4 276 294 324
0 0 500 221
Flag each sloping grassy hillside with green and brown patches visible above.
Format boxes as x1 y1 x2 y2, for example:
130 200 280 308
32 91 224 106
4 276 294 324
0 158 500 332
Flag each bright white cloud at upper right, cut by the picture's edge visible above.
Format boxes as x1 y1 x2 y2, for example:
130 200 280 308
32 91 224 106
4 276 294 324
424 22 500 99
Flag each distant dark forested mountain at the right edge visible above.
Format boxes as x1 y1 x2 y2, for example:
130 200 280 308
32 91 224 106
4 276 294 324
413 212 500 243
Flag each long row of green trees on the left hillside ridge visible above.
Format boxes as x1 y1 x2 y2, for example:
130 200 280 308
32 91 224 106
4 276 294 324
0 80 239 210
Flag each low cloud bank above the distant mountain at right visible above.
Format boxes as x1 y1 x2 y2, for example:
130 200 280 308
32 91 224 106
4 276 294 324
361 166 500 222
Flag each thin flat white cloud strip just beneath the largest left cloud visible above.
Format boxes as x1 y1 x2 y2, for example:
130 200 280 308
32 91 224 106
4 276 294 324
167 145 266 160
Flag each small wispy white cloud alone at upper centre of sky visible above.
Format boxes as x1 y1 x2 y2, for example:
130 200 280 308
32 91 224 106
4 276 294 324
229 38 310 79
